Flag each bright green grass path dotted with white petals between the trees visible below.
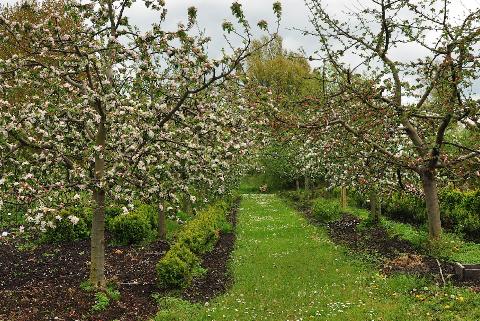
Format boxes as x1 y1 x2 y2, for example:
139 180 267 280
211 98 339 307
156 194 480 320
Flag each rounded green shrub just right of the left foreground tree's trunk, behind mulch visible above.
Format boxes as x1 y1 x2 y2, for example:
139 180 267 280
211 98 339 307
110 211 152 245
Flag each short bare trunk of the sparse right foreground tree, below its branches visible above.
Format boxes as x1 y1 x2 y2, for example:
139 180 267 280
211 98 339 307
421 170 442 239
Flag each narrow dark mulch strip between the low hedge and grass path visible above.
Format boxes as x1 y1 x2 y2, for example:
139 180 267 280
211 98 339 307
183 201 239 303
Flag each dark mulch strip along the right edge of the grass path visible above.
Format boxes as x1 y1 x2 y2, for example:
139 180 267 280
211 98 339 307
327 214 480 290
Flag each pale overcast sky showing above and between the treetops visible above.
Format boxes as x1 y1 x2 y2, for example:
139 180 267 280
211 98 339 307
0 0 480 91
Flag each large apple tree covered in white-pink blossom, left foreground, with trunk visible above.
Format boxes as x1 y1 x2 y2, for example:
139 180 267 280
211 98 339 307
0 0 281 286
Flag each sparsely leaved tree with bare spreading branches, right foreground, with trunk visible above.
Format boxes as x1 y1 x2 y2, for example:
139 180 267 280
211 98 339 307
307 0 480 238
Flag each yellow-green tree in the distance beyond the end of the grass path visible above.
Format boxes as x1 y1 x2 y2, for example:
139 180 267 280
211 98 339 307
247 37 319 188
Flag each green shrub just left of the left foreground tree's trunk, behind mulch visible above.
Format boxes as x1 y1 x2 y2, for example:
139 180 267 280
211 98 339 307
41 208 91 243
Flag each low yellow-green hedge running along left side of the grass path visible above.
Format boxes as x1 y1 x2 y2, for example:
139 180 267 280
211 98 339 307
156 201 232 289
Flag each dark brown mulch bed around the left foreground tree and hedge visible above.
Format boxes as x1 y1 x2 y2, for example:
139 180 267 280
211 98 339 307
0 202 240 321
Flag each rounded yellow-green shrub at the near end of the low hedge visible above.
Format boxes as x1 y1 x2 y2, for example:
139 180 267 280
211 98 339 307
156 244 205 288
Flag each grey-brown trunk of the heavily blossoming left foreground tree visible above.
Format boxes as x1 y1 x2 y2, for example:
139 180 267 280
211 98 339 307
90 119 106 288
